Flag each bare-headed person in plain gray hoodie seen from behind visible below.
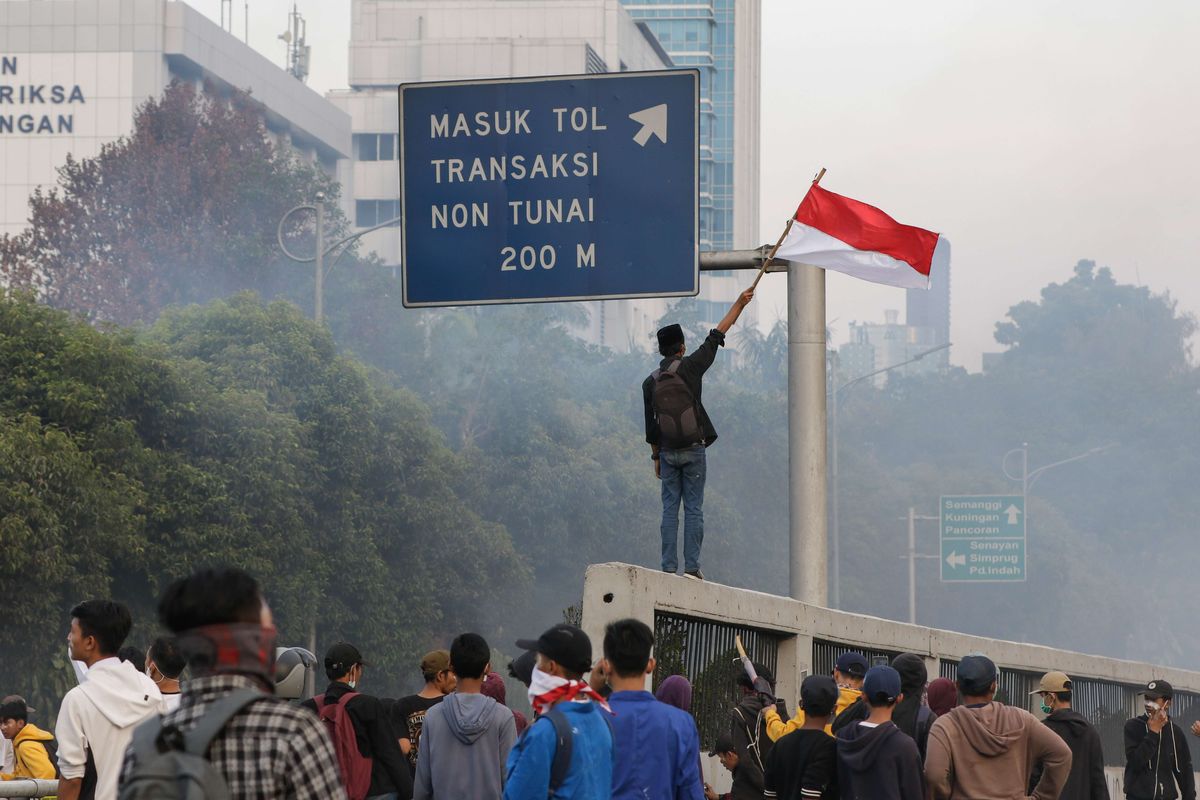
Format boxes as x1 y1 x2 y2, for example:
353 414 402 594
413 633 517 800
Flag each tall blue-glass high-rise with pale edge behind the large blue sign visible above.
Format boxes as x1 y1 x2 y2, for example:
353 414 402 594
622 0 761 256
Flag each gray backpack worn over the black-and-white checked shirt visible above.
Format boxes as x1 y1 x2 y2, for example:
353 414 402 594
118 688 266 800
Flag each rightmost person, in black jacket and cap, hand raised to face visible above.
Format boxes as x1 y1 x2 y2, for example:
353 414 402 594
1124 680 1196 800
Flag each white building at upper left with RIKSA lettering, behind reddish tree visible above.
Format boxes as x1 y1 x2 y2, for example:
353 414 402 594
0 0 350 234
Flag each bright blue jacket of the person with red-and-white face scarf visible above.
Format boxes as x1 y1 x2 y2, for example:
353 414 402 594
504 702 613 800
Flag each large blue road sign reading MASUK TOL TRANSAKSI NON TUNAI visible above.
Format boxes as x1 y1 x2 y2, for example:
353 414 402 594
400 70 700 307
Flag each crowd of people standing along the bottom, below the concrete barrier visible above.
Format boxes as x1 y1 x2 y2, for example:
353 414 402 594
0 569 1200 800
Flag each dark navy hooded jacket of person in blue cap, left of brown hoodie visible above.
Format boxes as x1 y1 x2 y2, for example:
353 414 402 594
838 722 925 800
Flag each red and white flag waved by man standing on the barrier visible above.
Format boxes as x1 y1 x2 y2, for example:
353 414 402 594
775 184 950 289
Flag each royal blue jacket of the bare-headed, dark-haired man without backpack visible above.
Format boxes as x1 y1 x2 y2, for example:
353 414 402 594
608 692 704 800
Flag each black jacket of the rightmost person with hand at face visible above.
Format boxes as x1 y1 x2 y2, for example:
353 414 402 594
1124 714 1196 800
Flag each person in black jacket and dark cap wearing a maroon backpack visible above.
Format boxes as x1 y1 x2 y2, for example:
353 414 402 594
300 642 413 800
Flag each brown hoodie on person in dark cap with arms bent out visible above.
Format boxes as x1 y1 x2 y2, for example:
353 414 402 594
925 703 1070 800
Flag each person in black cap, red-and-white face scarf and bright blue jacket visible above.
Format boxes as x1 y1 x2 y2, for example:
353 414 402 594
504 625 614 800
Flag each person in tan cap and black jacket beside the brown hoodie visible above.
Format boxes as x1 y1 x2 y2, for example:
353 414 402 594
1030 672 1109 800
